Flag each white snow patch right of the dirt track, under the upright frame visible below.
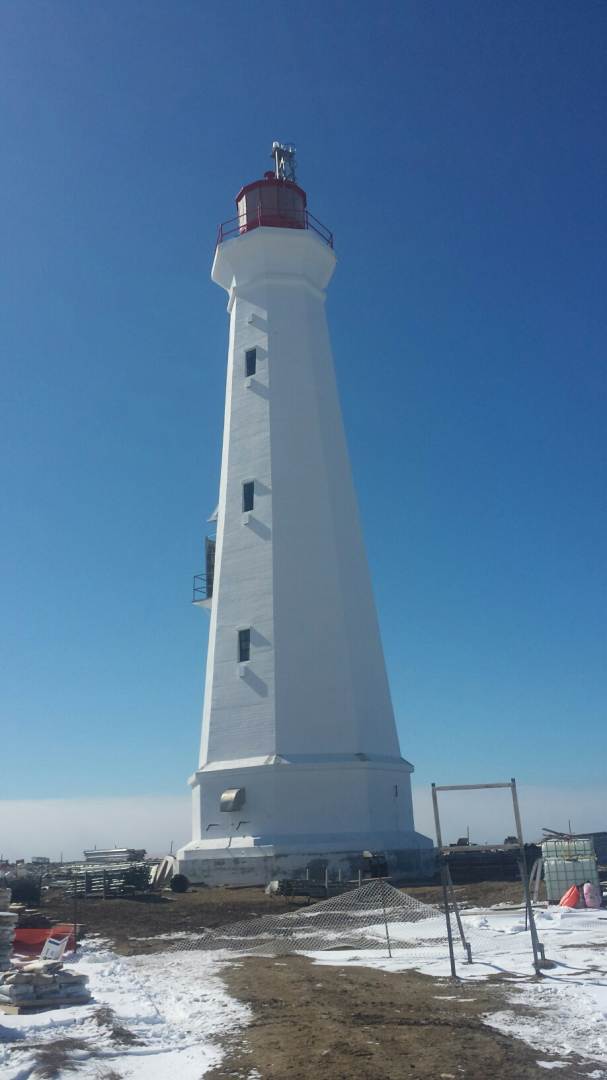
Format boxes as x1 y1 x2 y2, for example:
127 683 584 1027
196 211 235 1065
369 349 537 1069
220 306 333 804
307 908 607 1080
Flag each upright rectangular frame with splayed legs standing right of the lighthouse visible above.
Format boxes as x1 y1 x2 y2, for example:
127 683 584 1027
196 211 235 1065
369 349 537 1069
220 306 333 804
432 777 549 978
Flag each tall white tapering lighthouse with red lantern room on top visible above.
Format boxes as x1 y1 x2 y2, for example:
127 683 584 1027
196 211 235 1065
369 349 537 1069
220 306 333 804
177 143 432 885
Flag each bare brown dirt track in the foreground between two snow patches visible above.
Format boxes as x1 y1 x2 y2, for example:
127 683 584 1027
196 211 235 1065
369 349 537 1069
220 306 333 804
207 956 593 1080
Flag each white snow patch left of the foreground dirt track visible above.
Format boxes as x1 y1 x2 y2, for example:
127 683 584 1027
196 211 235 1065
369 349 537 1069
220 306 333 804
0 939 251 1080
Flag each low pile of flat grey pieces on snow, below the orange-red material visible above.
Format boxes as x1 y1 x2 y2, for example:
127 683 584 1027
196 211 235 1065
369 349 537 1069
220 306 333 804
0 960 91 1012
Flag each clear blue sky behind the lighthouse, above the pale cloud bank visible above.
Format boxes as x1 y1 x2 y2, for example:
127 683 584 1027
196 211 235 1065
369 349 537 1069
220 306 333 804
0 0 607 812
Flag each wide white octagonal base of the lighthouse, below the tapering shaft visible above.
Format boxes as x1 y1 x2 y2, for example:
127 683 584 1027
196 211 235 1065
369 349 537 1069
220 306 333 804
177 754 434 886
